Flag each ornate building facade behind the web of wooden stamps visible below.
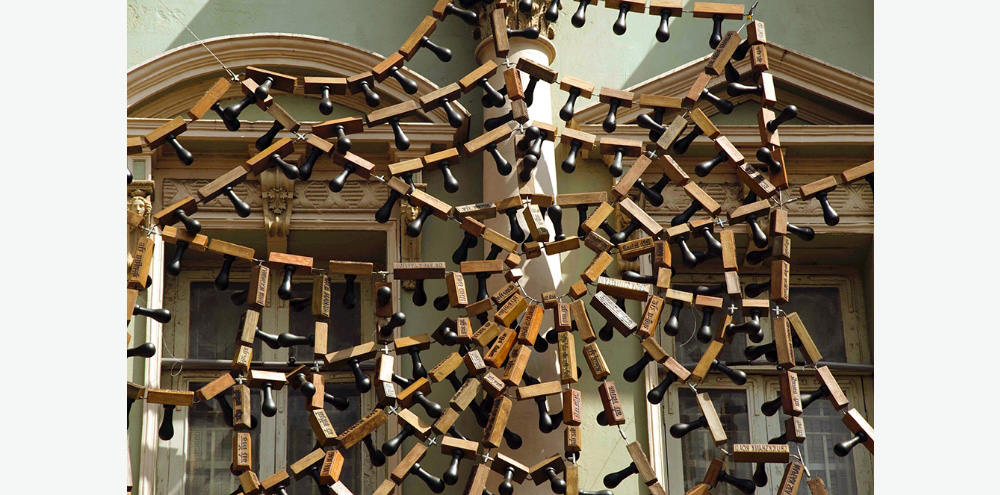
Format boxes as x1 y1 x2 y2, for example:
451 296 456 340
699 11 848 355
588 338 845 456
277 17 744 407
127 0 874 495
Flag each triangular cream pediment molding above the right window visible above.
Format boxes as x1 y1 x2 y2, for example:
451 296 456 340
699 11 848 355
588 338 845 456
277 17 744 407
574 42 875 126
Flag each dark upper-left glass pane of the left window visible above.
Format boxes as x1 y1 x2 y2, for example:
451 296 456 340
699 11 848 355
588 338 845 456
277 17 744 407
188 282 260 360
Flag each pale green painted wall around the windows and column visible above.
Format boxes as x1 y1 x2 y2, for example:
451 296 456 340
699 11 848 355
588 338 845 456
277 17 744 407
128 0 874 495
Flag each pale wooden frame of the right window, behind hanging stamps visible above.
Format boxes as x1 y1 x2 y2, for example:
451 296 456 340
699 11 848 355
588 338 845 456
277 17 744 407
639 257 875 495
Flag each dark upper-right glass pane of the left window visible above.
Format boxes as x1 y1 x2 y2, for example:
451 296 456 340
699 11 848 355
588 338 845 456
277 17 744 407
288 282 361 362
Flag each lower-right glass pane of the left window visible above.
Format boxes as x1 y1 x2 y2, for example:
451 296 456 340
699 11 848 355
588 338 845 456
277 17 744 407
285 382 365 495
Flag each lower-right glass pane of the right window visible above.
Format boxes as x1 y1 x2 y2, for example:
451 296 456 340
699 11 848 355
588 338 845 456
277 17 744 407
791 399 864 493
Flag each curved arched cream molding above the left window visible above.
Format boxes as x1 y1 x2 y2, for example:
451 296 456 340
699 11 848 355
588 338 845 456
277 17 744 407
127 33 468 125
